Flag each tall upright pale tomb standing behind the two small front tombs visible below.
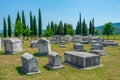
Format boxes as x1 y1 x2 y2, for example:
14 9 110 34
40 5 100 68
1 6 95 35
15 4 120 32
37 39 51 56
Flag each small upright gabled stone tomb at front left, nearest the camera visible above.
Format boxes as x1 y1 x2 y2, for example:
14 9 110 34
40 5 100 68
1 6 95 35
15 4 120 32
21 53 40 75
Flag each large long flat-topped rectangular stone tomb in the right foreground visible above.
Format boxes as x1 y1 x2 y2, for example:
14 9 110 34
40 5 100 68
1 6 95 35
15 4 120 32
64 52 101 69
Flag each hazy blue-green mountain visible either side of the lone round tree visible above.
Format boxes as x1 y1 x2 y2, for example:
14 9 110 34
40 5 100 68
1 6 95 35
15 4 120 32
96 22 120 35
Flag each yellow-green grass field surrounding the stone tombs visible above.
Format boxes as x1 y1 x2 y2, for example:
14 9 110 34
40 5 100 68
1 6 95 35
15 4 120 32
0 40 120 80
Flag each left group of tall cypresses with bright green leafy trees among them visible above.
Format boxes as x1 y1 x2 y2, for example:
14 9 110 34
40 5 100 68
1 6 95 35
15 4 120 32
3 9 42 39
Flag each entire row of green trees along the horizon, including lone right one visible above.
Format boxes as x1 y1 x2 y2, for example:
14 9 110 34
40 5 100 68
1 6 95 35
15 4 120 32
3 9 114 39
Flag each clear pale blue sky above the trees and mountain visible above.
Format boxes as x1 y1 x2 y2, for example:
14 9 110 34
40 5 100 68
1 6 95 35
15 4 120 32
0 0 120 30
